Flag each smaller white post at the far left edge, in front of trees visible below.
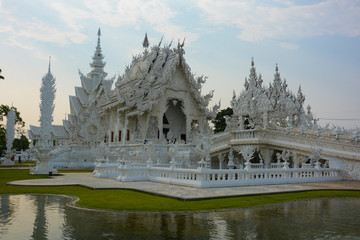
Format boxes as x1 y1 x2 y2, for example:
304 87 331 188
2 108 16 165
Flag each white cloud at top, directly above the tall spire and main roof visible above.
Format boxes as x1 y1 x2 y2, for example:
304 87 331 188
51 0 198 42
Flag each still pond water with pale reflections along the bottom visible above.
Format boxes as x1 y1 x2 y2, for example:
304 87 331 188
0 195 360 240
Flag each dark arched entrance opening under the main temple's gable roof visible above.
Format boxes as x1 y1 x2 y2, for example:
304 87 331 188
162 99 186 142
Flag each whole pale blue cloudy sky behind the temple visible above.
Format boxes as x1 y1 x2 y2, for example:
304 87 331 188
0 0 360 133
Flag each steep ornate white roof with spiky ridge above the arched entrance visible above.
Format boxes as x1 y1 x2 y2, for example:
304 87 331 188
104 35 217 114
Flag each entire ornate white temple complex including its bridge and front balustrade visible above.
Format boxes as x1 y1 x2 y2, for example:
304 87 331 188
29 29 360 187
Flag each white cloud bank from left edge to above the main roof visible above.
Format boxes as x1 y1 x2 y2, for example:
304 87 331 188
0 0 198 49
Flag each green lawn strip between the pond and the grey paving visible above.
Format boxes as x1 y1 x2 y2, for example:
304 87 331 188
0 169 360 211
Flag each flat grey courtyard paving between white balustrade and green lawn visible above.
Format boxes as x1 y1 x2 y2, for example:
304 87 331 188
8 173 360 200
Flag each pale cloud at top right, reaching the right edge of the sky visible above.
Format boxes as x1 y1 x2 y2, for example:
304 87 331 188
198 0 360 41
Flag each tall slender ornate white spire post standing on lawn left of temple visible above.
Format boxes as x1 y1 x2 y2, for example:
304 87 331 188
30 57 57 175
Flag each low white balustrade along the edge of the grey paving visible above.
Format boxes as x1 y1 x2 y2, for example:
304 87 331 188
94 165 341 188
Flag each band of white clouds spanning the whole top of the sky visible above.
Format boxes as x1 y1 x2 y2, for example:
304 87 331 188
0 0 360 50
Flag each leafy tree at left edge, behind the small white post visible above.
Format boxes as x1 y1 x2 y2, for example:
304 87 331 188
0 104 25 155
